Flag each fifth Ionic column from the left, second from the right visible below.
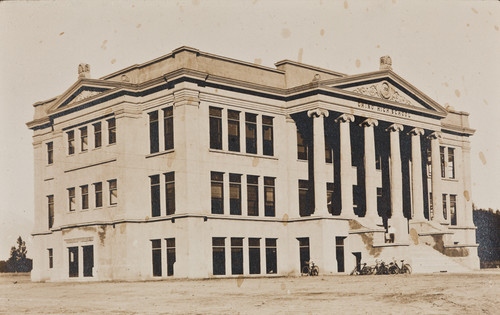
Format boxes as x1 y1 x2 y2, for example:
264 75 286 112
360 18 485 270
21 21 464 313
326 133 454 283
409 128 425 221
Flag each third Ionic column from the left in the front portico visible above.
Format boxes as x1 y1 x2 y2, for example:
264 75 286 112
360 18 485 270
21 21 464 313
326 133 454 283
360 118 380 223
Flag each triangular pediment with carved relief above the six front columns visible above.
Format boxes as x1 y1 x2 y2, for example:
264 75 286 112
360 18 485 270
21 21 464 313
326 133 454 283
323 70 447 116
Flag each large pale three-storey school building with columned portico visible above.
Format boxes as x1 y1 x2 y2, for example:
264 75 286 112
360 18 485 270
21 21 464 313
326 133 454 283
27 47 479 281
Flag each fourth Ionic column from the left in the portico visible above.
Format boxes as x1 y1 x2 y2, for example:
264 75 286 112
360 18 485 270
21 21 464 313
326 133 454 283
387 124 404 219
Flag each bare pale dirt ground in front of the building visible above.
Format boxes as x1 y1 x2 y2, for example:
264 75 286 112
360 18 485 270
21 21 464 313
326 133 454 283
0 271 500 314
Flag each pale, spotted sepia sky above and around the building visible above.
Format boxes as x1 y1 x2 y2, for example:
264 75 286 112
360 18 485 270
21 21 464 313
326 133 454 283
0 0 500 259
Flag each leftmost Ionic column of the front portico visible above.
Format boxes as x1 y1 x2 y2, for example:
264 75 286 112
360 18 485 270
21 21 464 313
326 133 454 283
307 108 330 216
